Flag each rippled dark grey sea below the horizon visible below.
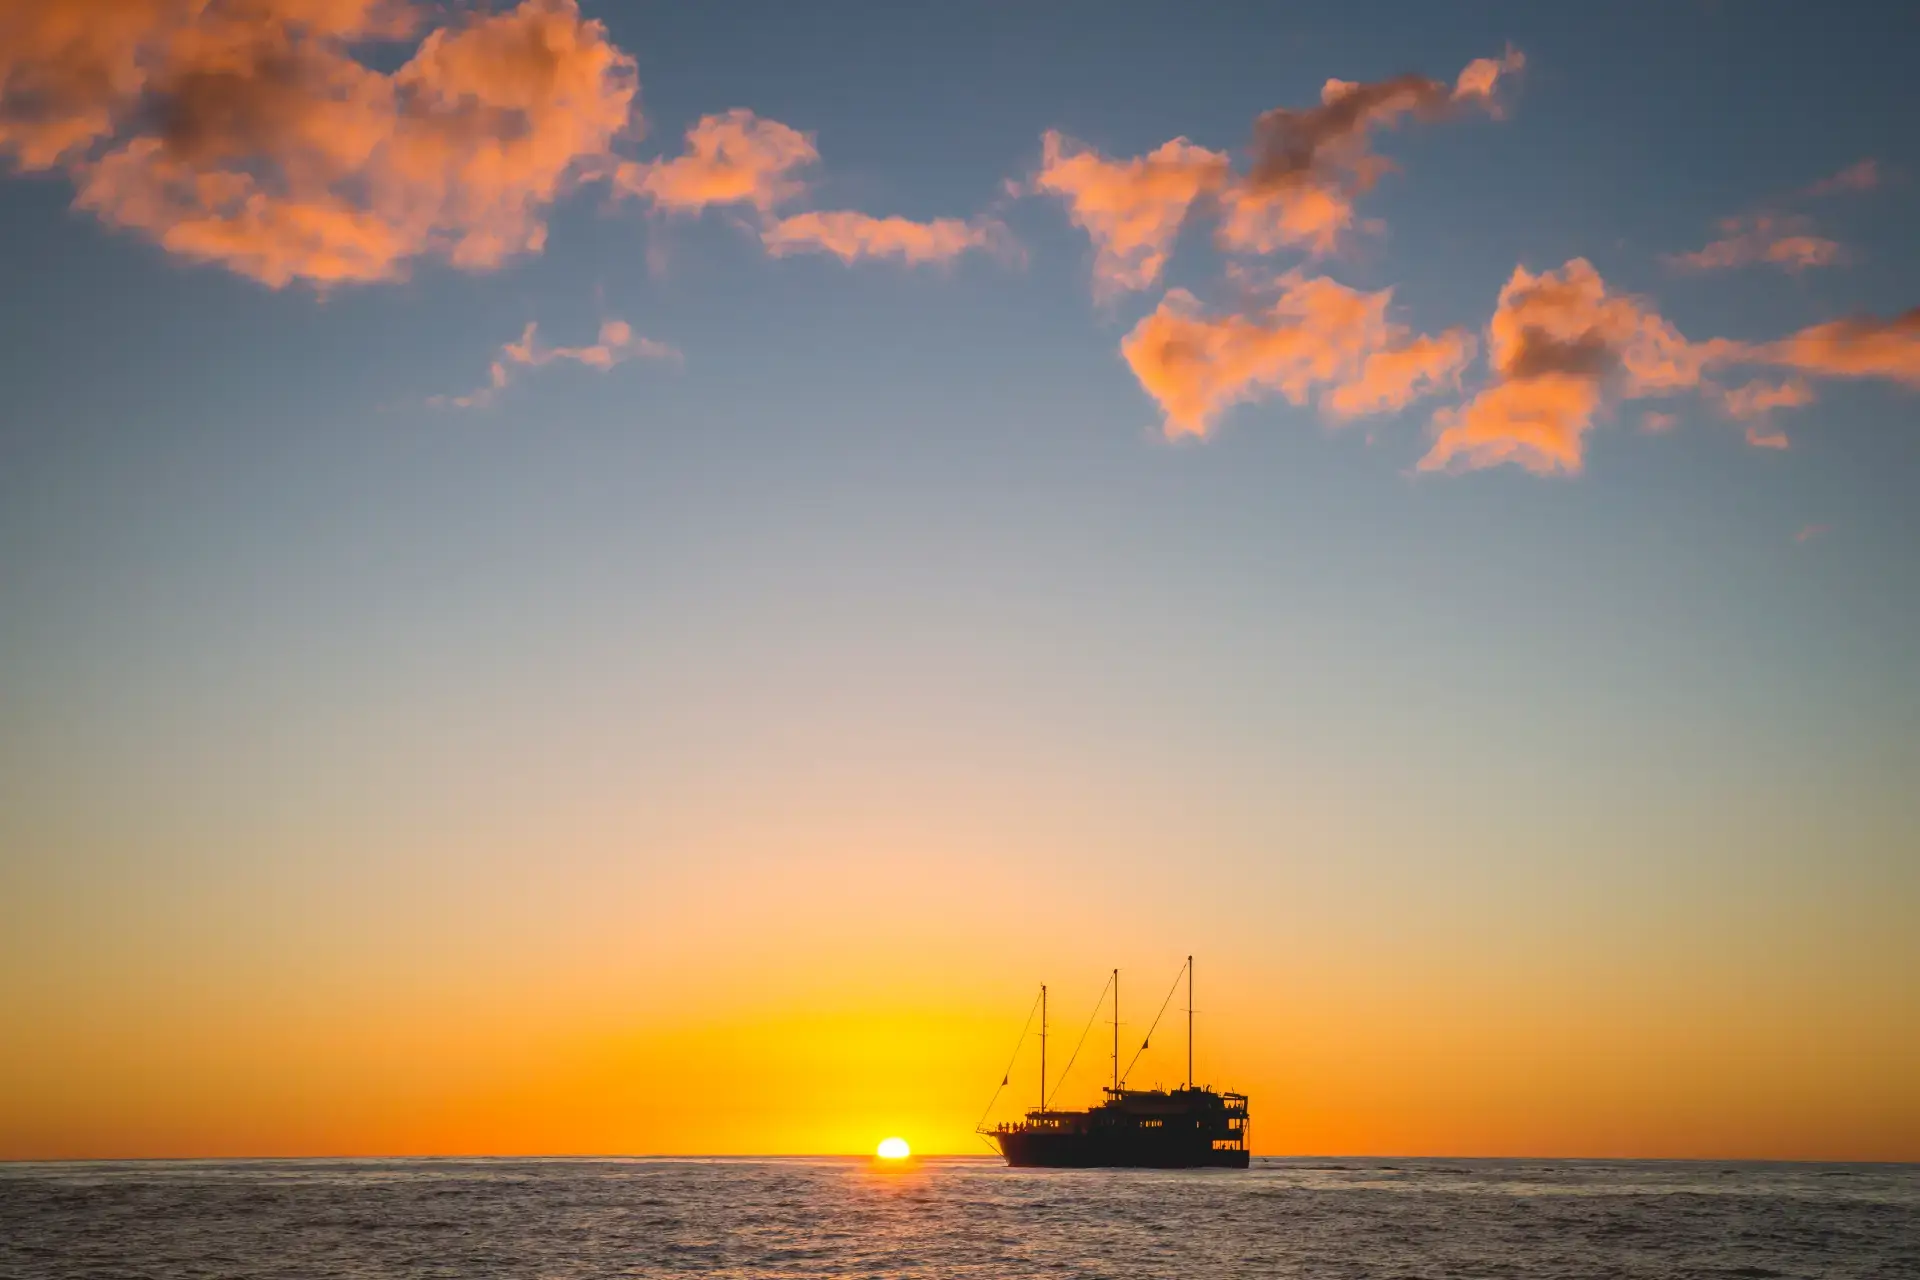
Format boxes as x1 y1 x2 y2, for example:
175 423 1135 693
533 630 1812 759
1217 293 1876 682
0 1159 1920 1280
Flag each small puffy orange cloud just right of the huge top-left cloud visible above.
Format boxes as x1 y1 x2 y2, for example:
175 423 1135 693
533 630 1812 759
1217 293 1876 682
614 107 820 213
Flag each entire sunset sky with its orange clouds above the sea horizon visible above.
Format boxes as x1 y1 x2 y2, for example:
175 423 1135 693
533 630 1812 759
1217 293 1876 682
0 0 1920 1159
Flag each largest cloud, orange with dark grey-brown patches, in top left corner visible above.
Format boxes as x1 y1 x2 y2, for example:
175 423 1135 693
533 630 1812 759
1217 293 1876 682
0 0 637 286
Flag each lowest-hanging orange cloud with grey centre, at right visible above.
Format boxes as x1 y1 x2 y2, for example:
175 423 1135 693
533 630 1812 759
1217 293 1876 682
1419 257 1741 474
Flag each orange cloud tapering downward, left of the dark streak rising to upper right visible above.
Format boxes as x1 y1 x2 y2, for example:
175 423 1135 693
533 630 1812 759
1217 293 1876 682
1033 130 1227 296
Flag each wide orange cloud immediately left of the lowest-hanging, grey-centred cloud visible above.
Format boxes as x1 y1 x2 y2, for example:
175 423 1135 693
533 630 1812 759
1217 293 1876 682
1121 276 1475 438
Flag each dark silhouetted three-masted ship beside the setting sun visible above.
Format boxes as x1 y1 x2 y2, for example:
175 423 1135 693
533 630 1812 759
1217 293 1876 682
977 956 1250 1169
